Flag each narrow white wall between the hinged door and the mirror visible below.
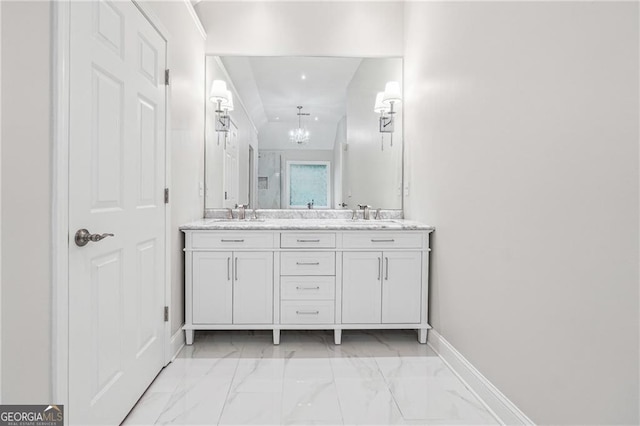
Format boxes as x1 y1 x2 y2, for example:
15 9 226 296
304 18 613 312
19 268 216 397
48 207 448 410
149 1 205 340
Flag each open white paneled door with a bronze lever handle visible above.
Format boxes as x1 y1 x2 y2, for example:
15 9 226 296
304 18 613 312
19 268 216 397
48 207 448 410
68 0 166 425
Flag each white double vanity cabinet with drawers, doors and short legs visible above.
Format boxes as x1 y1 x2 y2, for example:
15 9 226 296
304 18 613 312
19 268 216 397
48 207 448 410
183 228 431 345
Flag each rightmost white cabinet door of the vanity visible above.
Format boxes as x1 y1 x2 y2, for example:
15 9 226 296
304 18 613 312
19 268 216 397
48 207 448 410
382 251 422 324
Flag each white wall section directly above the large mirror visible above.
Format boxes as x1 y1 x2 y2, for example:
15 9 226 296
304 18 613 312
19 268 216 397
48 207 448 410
196 1 403 57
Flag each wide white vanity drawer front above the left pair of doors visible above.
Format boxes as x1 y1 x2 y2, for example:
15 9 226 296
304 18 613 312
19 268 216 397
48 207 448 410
191 231 274 249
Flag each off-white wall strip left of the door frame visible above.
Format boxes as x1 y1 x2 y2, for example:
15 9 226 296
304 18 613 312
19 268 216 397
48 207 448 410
0 1 52 404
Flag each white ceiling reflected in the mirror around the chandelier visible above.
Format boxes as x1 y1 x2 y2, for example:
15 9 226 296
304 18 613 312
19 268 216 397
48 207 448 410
221 56 362 149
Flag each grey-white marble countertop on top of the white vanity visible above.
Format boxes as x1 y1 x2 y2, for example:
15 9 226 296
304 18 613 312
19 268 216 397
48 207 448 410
180 219 435 232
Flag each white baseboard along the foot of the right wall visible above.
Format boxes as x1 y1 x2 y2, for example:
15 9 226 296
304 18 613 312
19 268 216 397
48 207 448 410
428 329 535 425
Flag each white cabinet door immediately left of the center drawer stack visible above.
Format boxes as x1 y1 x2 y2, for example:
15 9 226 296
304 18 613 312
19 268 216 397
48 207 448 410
233 252 273 324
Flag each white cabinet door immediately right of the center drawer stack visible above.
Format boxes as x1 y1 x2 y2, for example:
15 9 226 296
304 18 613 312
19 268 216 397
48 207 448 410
342 252 382 324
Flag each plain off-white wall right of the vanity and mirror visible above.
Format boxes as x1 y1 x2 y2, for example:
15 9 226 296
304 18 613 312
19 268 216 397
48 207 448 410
405 2 640 424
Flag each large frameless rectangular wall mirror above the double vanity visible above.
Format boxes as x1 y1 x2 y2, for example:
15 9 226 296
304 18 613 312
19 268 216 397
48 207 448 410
205 56 403 209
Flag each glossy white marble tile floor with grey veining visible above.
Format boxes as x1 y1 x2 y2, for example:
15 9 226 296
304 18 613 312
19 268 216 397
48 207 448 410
123 330 499 425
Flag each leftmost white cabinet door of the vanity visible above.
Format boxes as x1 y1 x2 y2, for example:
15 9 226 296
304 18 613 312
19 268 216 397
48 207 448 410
192 251 233 324
